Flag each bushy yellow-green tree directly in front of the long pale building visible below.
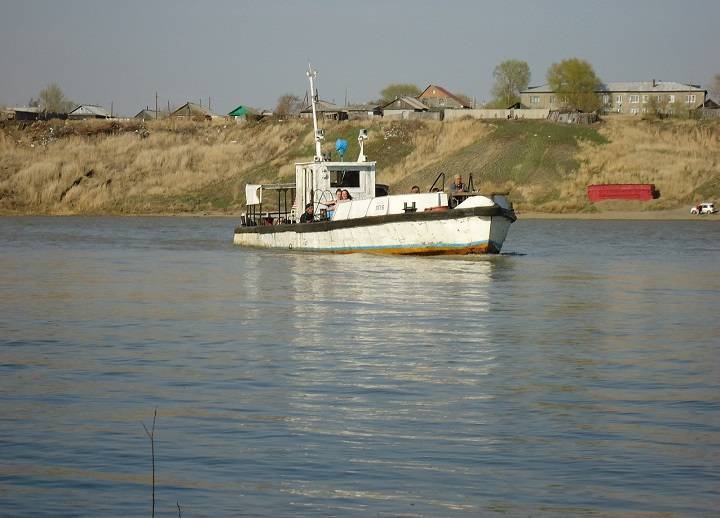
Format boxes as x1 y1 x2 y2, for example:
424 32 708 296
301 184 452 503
547 58 601 112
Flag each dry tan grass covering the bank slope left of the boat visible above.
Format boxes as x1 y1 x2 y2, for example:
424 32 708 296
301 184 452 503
0 121 307 214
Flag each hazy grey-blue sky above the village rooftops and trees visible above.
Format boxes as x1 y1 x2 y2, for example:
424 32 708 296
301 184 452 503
0 0 720 115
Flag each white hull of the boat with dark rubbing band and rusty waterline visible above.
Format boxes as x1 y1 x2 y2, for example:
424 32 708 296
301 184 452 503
234 206 515 255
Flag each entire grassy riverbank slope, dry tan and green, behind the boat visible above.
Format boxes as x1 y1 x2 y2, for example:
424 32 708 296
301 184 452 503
0 117 720 215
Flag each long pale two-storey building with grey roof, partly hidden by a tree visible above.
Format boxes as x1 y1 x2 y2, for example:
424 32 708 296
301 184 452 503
520 79 707 115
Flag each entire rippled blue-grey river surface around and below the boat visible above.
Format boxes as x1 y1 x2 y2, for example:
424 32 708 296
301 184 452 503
0 217 720 517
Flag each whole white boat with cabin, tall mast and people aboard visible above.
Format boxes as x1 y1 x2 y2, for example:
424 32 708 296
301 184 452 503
233 67 516 255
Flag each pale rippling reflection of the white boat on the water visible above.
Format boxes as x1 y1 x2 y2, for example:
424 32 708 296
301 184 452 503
272 254 507 510
